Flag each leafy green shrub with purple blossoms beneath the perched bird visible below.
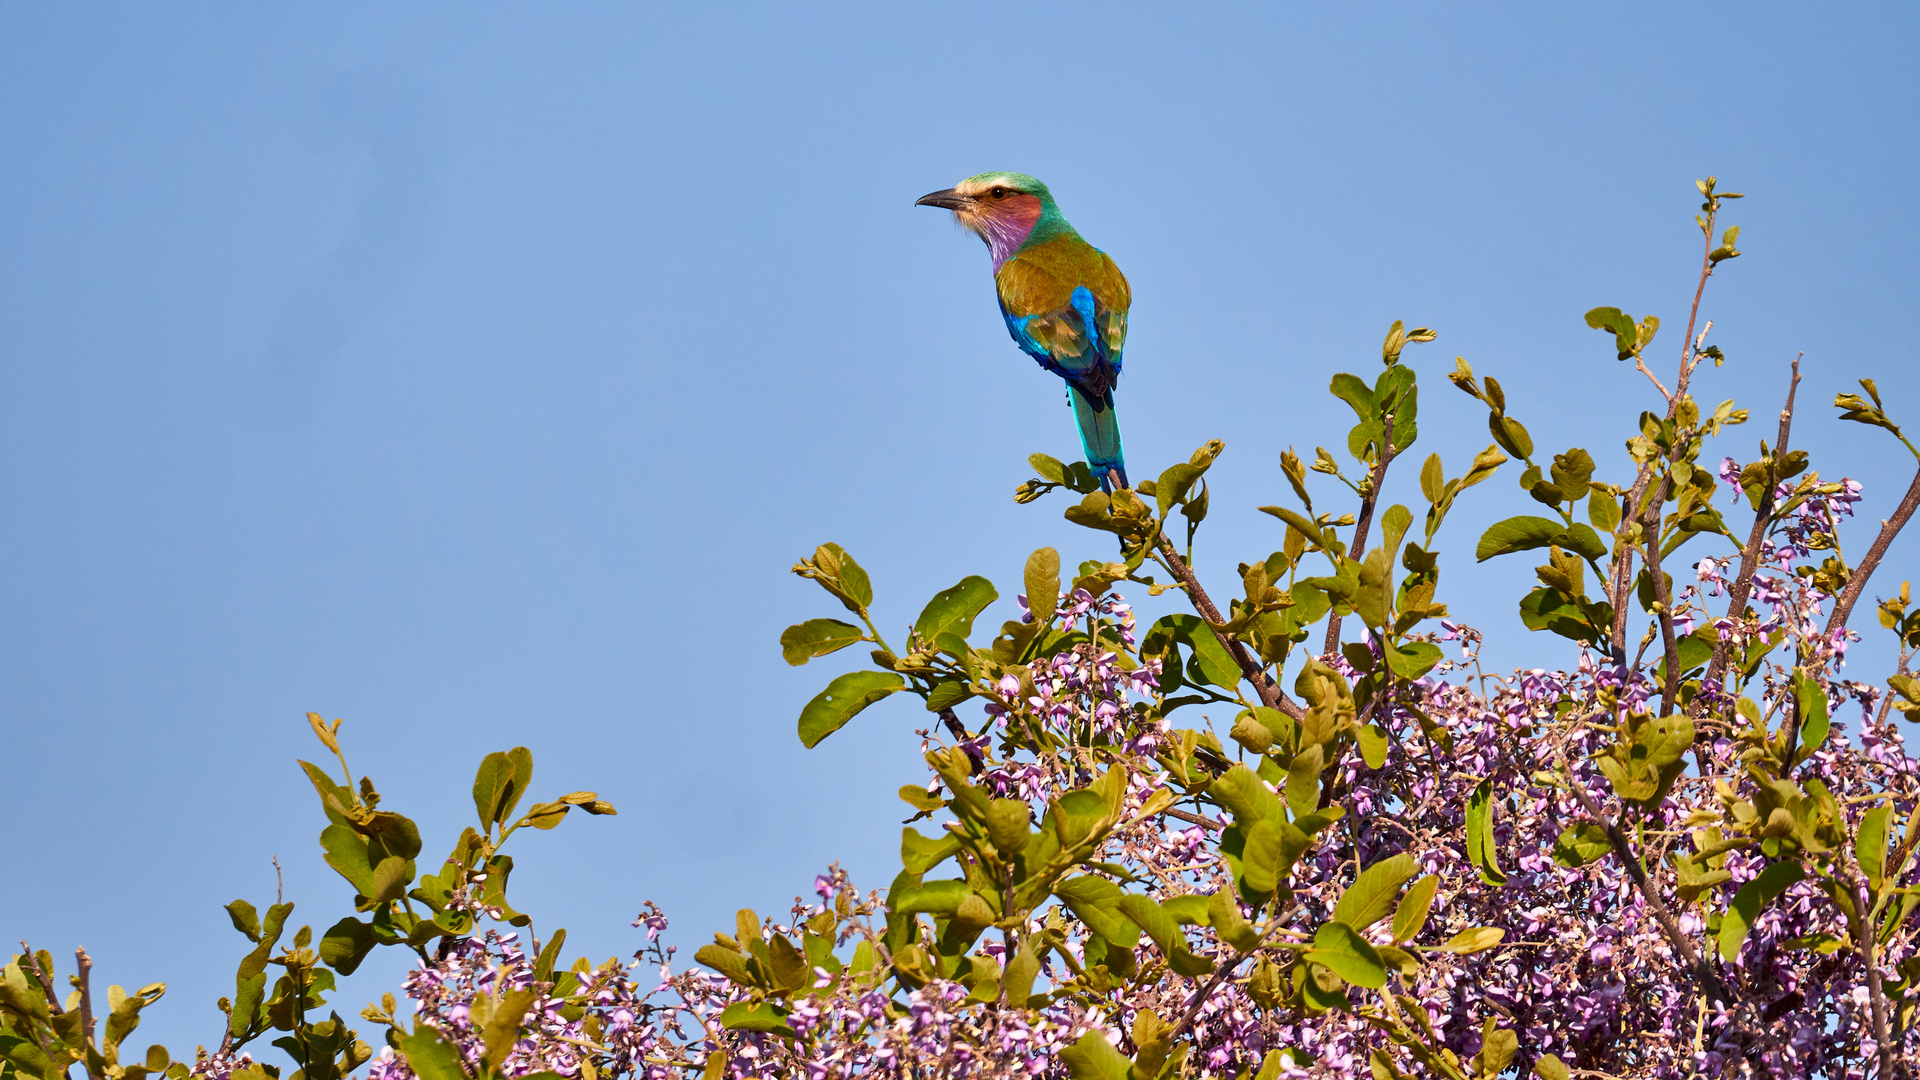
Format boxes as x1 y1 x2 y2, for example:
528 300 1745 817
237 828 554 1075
0 181 1920 1080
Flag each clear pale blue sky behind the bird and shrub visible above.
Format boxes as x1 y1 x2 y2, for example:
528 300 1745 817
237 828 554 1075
0 0 1920 1055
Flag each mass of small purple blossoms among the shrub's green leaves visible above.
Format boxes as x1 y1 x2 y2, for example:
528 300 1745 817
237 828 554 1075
349 482 1920 1080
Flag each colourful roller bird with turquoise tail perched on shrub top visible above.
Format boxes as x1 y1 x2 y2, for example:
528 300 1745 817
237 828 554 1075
914 173 1133 492
